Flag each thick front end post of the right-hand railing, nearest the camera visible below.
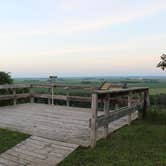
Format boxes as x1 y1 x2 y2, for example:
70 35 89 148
90 93 98 148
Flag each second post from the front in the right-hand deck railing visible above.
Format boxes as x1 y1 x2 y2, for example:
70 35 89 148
104 94 110 138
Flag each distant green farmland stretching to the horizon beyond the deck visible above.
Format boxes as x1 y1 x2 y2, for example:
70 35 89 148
14 77 166 95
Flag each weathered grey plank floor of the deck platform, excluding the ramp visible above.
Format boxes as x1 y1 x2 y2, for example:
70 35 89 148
0 104 136 147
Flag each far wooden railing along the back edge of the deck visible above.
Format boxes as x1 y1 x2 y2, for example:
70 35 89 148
0 84 96 106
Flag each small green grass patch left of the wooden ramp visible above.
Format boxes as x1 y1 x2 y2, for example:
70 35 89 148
0 129 29 153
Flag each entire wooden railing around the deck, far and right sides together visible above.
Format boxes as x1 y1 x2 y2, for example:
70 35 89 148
0 84 149 147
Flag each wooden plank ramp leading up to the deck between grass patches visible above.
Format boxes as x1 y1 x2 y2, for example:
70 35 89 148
0 136 78 166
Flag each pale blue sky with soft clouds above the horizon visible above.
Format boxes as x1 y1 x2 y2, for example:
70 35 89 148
0 0 166 77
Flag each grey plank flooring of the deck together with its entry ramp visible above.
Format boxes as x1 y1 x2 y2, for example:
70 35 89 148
0 104 137 166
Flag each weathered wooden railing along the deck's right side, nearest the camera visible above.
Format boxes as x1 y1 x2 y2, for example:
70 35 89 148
90 88 149 148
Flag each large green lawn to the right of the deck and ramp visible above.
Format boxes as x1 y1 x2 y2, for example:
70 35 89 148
58 120 166 166
